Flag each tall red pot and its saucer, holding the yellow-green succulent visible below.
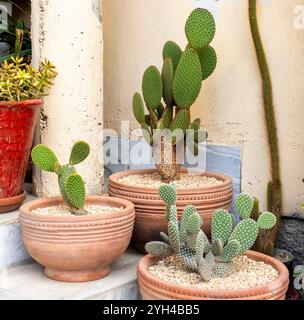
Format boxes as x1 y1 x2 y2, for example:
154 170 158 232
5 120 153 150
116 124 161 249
0 99 42 213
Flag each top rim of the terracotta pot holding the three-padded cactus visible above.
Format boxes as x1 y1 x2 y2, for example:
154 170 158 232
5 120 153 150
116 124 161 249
19 196 135 223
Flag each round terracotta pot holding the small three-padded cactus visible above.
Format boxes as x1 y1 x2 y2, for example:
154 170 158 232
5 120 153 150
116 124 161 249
20 197 135 282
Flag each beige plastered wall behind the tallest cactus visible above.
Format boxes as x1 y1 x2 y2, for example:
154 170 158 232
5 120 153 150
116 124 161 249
104 0 304 213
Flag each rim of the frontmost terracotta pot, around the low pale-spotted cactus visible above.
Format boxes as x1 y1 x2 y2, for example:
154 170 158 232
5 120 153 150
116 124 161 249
137 250 289 299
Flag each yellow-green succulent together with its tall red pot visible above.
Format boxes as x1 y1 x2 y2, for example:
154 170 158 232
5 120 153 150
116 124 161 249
0 57 56 213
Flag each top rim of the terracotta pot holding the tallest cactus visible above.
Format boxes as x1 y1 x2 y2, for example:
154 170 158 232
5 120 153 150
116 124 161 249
109 169 232 194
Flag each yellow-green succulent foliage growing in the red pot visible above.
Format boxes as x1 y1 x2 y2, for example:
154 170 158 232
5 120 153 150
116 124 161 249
0 57 57 101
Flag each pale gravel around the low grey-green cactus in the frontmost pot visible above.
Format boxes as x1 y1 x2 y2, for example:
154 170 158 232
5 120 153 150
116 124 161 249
149 255 279 290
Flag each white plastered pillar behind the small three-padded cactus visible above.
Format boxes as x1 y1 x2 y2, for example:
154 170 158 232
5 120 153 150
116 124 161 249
32 0 103 196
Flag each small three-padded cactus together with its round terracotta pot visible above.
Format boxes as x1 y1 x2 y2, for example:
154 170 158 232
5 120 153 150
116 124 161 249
20 141 135 282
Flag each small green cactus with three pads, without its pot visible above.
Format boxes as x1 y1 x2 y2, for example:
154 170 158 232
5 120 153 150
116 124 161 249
32 141 90 215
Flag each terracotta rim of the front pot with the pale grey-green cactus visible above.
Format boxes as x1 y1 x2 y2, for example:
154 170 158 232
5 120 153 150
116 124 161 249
137 251 289 299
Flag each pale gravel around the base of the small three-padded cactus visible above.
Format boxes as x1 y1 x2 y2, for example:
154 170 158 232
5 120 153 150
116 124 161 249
31 204 123 216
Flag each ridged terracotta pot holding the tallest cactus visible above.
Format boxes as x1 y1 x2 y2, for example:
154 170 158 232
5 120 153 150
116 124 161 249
108 169 233 253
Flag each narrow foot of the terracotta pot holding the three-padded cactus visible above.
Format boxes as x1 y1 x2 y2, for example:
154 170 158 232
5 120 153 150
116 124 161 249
44 266 111 282
